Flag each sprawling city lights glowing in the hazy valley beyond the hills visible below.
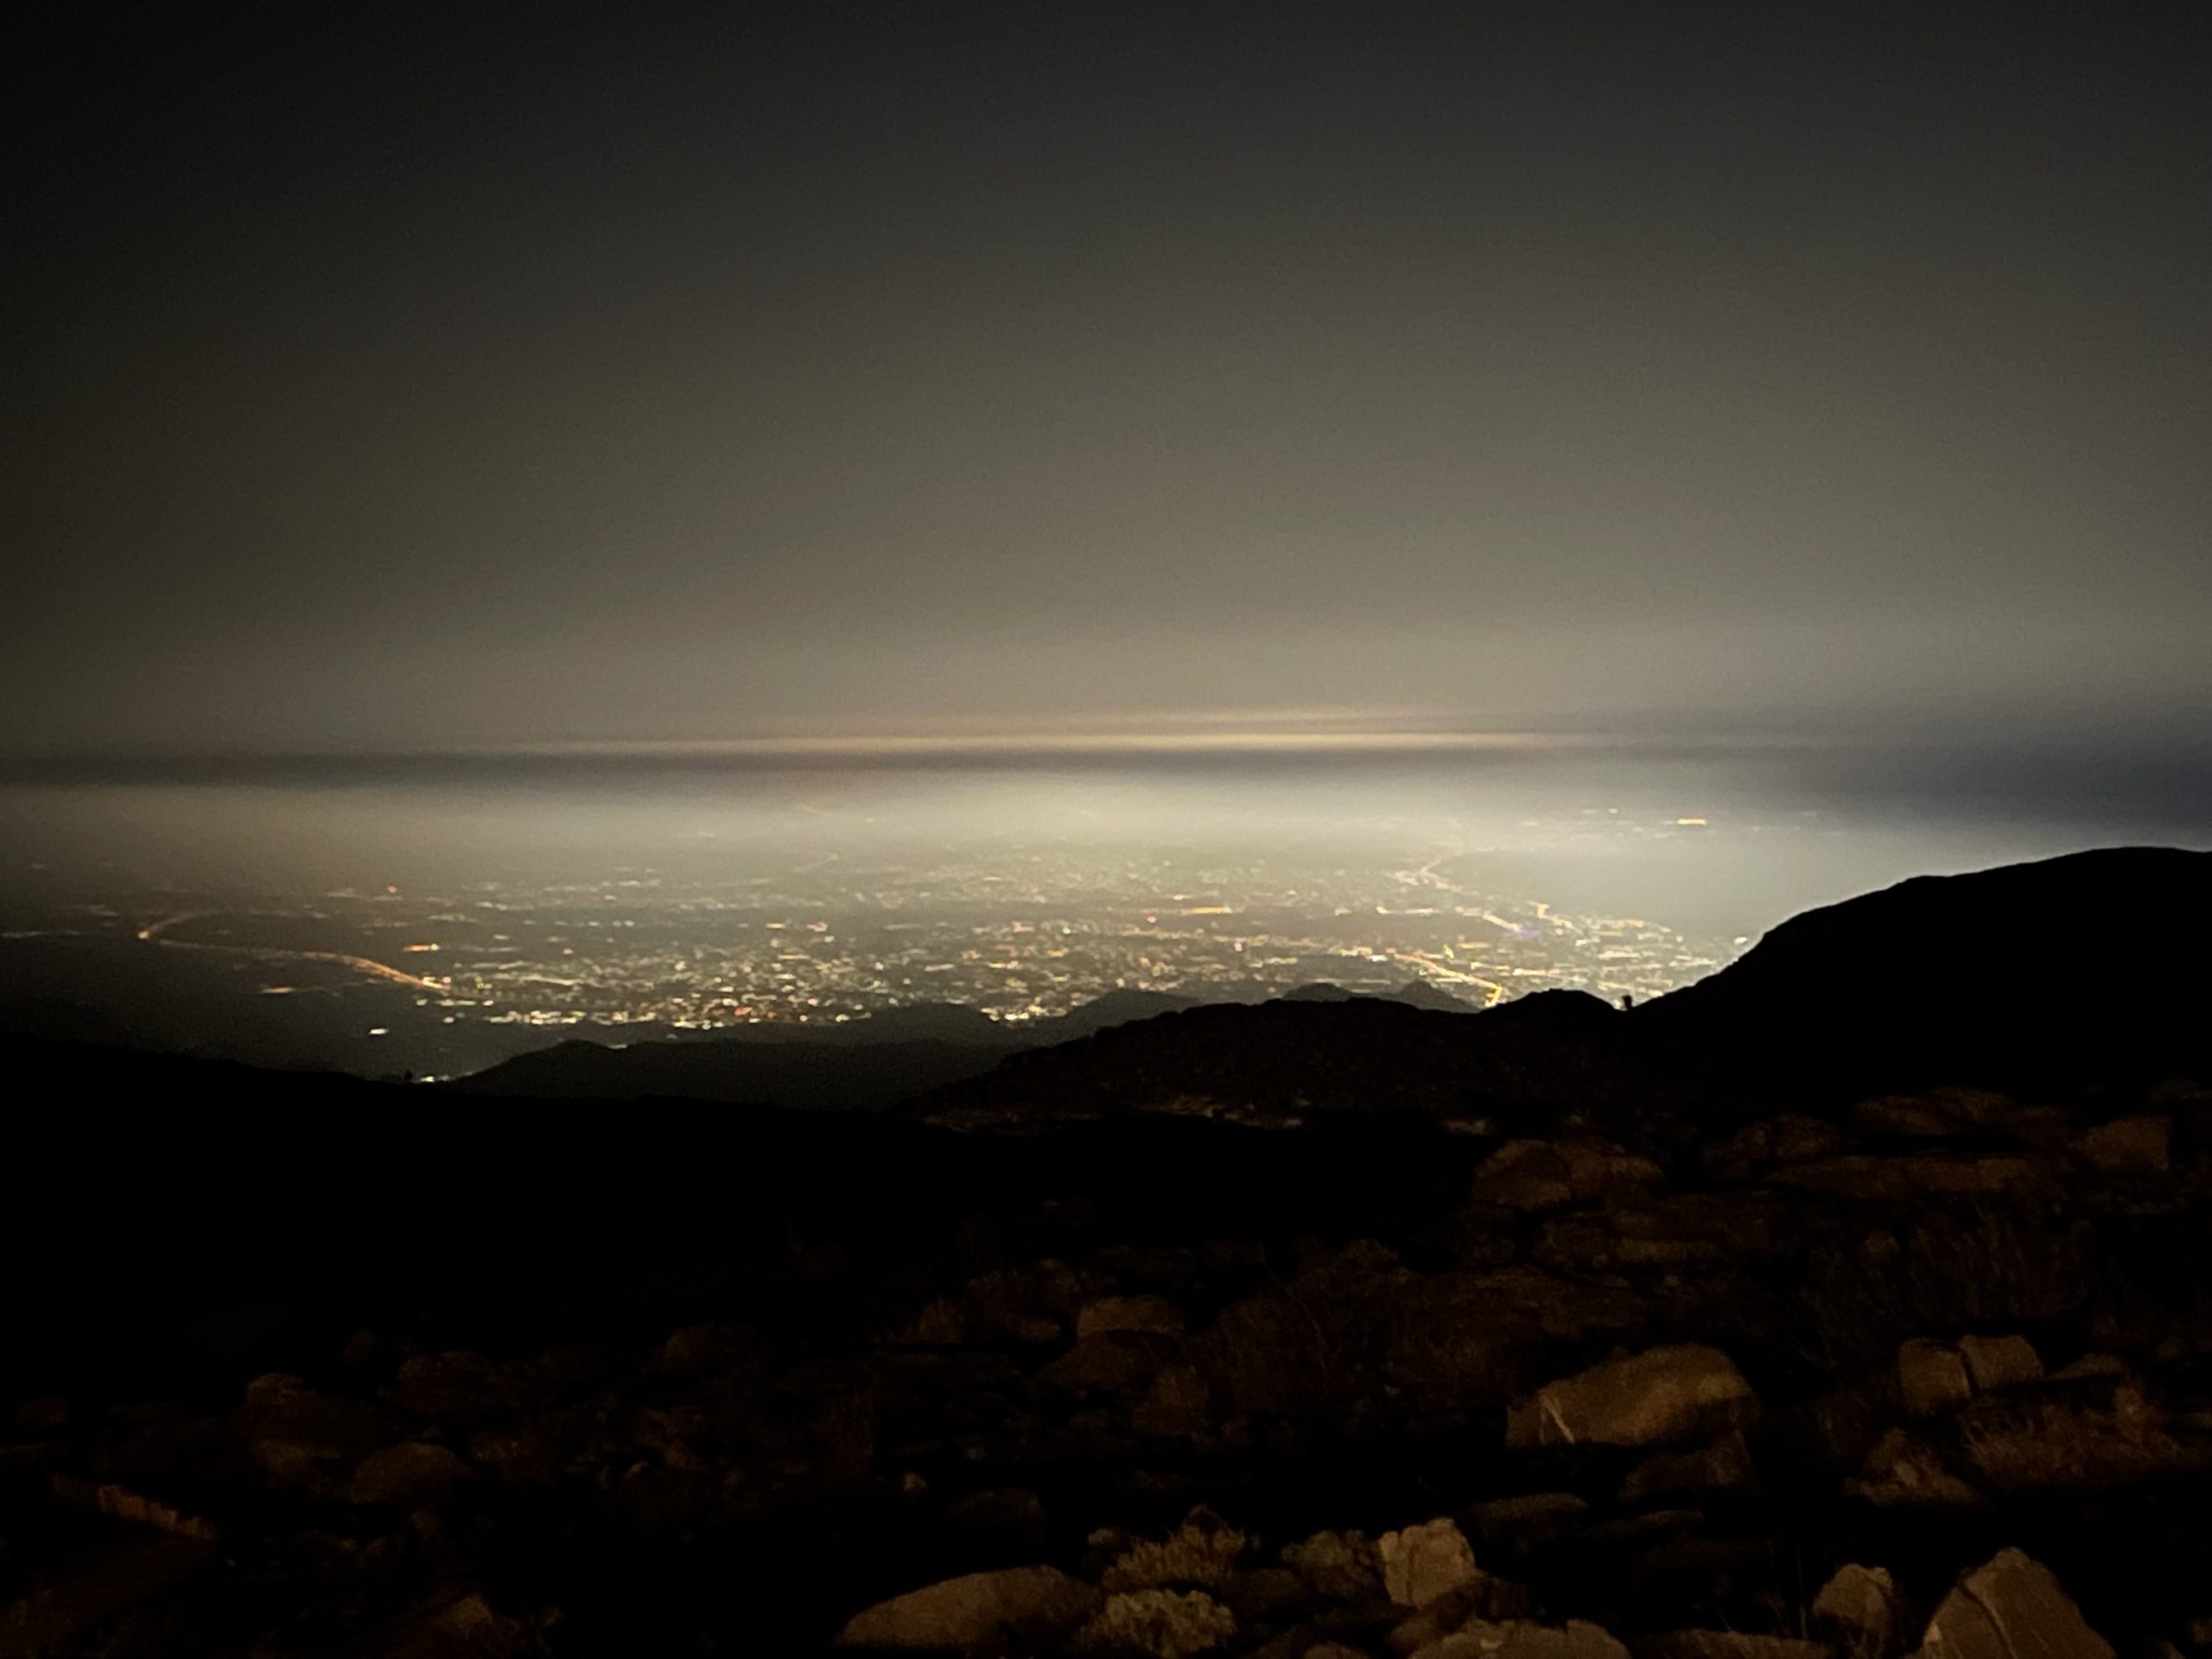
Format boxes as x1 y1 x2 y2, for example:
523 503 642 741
11 845 1737 1068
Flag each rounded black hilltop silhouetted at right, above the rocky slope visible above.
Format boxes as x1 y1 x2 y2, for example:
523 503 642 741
1635 847 2212 1093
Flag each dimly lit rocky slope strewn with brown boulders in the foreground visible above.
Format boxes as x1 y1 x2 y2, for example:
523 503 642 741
0 1079 2212 1659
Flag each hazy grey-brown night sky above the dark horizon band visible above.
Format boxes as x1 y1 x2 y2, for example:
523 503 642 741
0 4 2212 752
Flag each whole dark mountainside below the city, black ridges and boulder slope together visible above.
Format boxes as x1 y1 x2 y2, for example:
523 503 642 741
0 849 2212 1659
